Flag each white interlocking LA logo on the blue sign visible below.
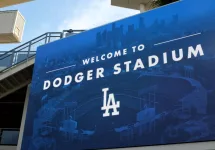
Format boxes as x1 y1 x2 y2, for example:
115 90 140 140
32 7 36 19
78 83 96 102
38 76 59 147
101 88 120 117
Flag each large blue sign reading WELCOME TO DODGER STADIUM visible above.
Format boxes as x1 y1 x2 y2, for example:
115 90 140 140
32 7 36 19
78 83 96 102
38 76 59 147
22 0 215 150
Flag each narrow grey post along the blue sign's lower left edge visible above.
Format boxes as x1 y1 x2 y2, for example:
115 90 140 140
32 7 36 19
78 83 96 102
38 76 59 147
16 84 31 150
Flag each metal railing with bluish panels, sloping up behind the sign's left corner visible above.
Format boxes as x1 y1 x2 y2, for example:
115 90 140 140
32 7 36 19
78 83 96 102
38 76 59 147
0 32 63 73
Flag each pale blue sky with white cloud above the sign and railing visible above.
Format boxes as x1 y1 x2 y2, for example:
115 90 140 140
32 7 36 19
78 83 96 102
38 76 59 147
0 0 139 51
